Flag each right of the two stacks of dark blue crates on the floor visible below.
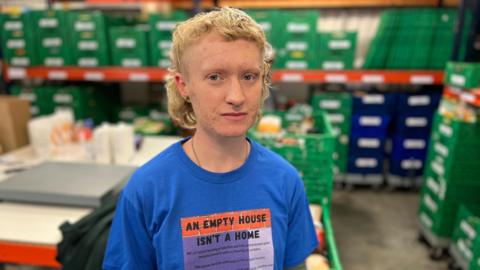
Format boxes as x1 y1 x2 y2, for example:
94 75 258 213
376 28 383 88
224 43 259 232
389 92 441 178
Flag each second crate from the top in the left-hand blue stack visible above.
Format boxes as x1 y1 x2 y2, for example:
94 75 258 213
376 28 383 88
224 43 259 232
351 115 390 137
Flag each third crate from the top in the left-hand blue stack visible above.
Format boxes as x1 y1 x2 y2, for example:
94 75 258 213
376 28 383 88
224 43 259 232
349 134 385 155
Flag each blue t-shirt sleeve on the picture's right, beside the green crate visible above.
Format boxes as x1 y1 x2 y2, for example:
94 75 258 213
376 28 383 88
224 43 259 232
284 176 318 267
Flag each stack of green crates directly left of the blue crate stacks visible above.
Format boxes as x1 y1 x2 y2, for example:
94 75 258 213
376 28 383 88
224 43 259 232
311 92 352 174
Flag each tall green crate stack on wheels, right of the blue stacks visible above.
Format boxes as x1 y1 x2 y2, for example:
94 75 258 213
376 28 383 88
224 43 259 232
418 110 480 244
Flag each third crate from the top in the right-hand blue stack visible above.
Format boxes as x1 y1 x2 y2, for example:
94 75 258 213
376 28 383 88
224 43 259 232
391 136 428 160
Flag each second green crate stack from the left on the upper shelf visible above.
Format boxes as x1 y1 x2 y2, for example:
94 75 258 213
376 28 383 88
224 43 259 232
32 10 72 67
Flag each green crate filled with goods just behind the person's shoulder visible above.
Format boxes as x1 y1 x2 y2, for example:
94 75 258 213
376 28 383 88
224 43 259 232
249 113 335 204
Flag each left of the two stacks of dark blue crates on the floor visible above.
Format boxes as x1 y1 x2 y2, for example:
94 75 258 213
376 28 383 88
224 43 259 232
348 93 395 176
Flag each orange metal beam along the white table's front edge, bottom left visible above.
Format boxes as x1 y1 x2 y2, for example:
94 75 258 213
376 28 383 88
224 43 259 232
0 242 61 268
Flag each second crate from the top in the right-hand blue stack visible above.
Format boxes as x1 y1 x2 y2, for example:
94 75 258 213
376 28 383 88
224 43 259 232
393 113 433 137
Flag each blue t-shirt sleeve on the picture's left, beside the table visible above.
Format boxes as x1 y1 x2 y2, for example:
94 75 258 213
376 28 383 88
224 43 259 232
103 191 156 269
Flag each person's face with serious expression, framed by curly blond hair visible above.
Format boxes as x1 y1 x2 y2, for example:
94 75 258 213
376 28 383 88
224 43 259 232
175 33 262 137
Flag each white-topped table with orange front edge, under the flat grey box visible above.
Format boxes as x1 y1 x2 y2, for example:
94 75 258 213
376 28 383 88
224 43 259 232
0 137 180 268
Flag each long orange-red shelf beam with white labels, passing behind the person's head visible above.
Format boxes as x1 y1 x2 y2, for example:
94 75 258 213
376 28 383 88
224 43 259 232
5 67 443 85
